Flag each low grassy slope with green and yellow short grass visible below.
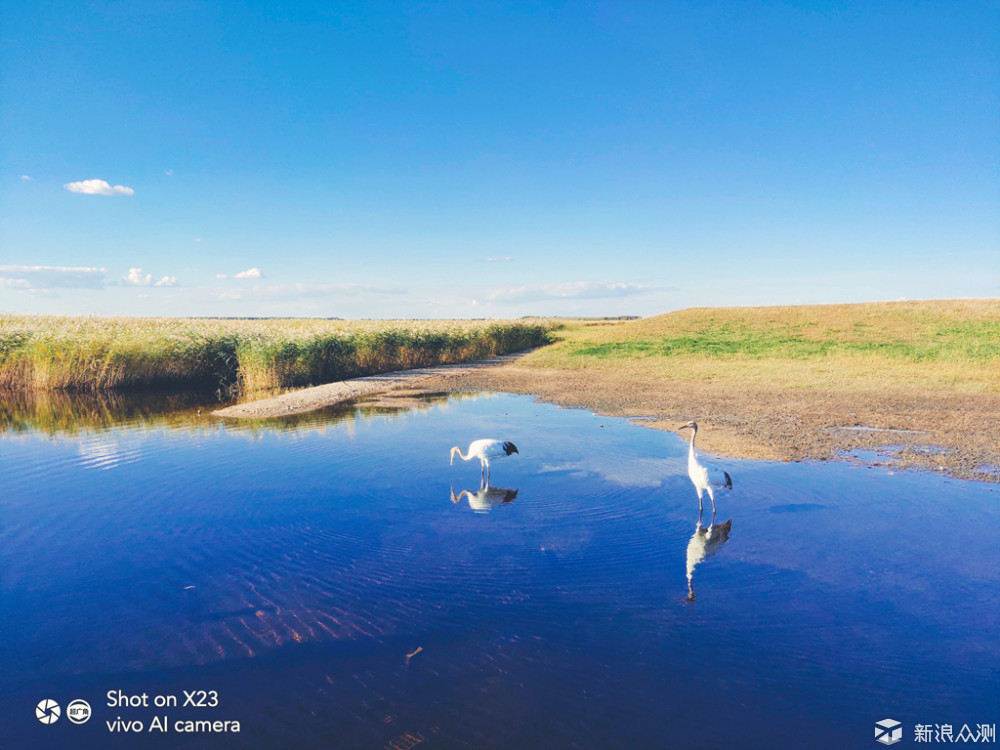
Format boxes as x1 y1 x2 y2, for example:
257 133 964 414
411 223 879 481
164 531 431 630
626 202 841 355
524 300 1000 390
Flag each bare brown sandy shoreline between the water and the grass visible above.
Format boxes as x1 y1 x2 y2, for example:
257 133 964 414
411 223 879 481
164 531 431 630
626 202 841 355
213 354 1000 482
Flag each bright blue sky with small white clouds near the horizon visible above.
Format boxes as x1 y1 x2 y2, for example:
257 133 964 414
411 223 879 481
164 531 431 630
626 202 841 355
0 0 1000 317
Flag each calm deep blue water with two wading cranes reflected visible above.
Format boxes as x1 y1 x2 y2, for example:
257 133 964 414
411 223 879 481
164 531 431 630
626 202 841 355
0 395 1000 750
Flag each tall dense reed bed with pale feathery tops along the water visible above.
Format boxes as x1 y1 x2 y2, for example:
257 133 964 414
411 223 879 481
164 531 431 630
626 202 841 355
0 315 551 392
